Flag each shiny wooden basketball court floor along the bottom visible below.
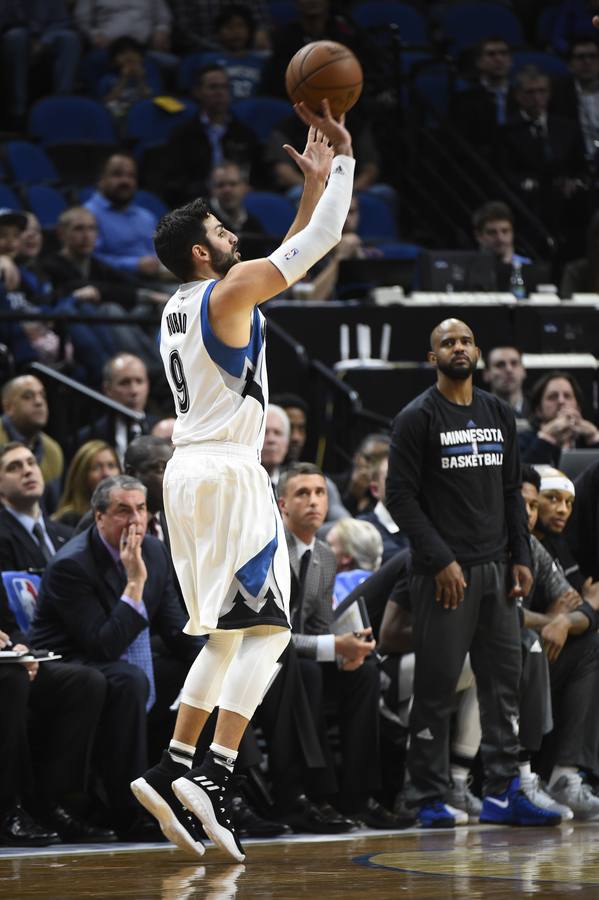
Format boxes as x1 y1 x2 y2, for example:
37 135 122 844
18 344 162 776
0 823 599 900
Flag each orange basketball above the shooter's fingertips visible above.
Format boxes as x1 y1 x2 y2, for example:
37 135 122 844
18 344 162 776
285 41 364 117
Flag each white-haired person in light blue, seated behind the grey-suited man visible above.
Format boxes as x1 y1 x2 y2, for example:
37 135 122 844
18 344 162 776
326 517 383 608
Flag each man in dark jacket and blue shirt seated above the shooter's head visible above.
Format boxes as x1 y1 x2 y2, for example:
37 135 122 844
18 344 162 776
162 64 264 206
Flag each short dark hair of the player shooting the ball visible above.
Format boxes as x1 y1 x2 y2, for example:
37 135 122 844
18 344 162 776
154 197 211 282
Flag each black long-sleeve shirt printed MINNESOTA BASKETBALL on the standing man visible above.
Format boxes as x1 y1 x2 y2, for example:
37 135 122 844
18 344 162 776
385 386 531 574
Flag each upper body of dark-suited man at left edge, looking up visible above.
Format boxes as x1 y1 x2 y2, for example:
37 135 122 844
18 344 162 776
0 441 73 571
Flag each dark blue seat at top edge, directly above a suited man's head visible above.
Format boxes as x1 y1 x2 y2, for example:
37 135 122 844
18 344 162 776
436 3 525 51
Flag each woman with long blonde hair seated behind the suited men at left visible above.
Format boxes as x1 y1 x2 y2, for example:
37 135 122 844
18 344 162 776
52 441 121 528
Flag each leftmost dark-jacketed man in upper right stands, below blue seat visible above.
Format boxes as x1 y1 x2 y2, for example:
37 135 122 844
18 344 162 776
451 36 515 154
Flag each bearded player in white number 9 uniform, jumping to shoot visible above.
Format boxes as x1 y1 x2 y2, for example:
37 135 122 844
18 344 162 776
131 101 355 861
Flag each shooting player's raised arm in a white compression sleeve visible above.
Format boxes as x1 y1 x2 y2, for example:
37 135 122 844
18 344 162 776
210 101 355 346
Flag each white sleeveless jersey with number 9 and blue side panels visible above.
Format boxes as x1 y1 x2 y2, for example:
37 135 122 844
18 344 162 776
160 280 268 452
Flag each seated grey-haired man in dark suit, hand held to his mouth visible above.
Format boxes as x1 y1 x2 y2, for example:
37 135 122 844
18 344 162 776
31 475 199 839
